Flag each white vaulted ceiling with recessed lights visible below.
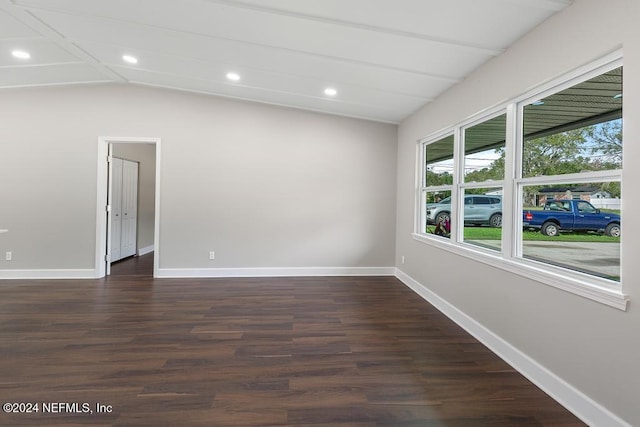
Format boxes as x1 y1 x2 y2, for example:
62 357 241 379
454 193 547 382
0 0 572 123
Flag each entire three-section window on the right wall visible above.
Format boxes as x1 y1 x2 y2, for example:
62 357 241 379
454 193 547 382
417 60 624 308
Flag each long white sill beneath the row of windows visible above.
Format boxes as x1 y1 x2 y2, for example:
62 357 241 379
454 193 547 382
412 233 629 311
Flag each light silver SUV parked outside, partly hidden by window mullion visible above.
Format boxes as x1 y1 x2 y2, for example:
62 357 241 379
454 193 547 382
427 194 502 227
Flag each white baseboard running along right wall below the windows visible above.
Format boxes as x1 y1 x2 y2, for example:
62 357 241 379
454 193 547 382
396 270 631 427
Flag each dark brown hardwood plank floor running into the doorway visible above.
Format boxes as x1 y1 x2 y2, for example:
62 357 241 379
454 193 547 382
0 255 583 426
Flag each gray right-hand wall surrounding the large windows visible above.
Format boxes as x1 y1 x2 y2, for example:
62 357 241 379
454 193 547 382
396 0 640 425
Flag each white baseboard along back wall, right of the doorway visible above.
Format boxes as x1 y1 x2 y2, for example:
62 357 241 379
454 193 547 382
157 267 396 278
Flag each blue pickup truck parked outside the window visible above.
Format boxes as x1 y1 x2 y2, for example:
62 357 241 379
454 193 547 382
522 200 621 237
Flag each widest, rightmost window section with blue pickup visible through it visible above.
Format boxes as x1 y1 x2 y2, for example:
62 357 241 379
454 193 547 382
518 67 623 282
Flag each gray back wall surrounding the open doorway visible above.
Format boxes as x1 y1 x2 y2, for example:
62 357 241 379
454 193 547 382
0 85 397 271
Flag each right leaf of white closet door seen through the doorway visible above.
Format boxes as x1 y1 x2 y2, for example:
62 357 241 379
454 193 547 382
120 160 138 258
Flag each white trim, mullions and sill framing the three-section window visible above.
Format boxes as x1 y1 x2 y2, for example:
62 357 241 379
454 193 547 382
412 50 629 311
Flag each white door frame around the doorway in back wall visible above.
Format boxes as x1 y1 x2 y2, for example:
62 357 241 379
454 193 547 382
95 136 161 278
